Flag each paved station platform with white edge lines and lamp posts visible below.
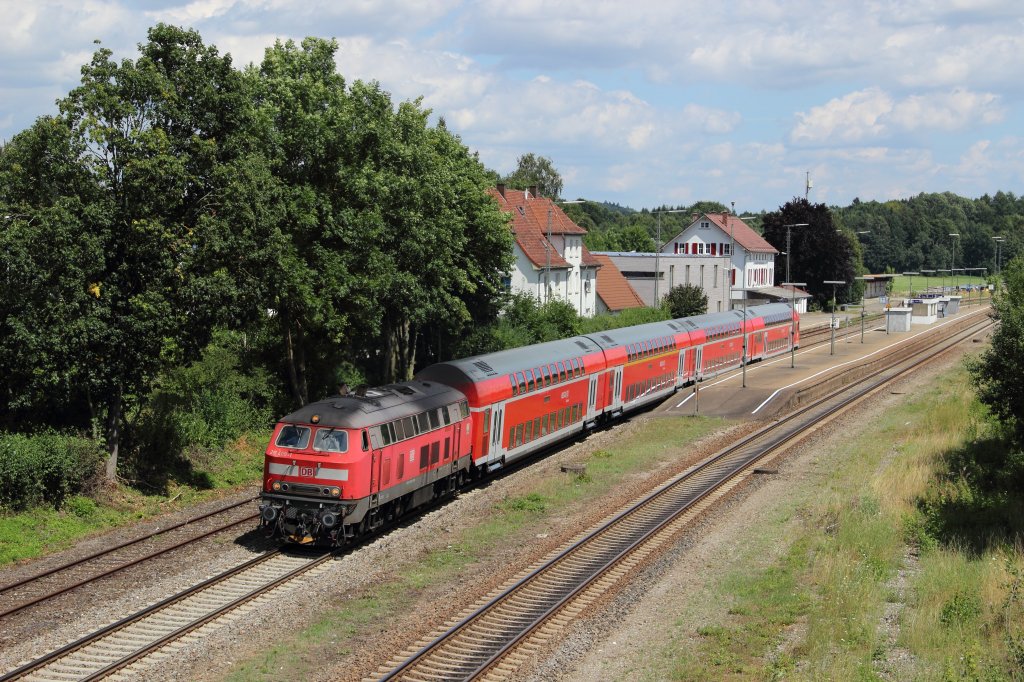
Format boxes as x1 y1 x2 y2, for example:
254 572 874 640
649 305 989 421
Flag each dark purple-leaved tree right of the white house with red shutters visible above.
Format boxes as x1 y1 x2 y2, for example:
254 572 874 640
764 199 859 305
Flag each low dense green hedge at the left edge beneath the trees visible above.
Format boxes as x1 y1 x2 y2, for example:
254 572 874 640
0 431 106 510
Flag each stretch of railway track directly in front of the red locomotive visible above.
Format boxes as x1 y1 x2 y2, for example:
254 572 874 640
0 551 332 682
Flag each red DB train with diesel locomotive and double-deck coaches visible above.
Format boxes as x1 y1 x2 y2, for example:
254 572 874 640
260 303 800 546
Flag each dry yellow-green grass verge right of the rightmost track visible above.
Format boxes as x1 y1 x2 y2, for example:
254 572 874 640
633 370 1024 680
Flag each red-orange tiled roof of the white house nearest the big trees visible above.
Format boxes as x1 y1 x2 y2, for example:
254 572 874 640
487 187 593 267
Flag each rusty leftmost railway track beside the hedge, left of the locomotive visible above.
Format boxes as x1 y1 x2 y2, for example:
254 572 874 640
0 497 258 620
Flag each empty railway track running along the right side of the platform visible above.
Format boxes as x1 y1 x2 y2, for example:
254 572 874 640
379 311 992 681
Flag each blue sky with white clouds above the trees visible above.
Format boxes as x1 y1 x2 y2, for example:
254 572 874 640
0 0 1024 211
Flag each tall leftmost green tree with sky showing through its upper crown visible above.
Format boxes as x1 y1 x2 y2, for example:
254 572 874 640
0 25 248 478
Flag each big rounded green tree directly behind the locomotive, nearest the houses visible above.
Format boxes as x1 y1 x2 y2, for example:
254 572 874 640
239 38 512 403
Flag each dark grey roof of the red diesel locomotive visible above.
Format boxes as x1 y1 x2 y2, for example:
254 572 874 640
281 380 466 429
